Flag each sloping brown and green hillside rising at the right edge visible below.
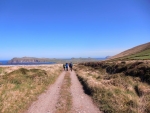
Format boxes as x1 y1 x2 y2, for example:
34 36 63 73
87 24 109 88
109 42 150 60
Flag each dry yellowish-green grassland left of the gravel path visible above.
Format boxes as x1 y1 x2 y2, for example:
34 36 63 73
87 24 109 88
0 66 60 113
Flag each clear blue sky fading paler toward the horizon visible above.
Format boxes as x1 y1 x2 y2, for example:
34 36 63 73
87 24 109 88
0 0 150 59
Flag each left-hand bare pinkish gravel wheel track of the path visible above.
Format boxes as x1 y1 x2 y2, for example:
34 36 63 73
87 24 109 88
25 72 66 113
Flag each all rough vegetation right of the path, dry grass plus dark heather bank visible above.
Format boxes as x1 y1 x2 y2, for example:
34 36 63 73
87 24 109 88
76 62 150 113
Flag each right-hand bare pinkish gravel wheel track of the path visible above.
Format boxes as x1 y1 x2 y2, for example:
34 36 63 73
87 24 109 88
70 71 101 113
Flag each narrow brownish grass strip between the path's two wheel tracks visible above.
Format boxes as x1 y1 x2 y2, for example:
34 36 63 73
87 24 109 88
56 72 72 113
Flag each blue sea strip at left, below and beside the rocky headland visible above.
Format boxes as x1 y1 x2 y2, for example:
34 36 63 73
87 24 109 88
0 60 55 65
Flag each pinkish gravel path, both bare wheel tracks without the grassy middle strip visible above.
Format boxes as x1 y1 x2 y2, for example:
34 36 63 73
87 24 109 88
25 71 101 113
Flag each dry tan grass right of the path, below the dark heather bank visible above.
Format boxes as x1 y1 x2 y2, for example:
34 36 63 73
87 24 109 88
76 65 150 113
